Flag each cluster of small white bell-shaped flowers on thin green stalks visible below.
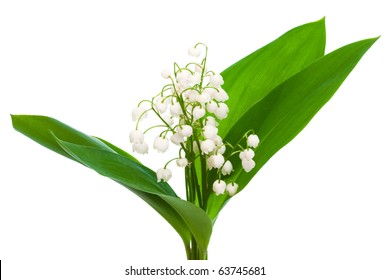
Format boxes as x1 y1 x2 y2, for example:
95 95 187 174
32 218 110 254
130 43 259 196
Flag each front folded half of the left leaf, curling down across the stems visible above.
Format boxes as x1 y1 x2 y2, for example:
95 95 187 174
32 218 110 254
58 140 212 255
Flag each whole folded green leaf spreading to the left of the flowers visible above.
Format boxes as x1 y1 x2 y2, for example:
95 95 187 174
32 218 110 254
12 115 212 255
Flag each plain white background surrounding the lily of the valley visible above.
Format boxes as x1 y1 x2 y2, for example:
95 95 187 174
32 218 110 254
0 0 390 280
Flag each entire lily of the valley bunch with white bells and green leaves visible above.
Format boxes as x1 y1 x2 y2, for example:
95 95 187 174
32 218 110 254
12 19 377 260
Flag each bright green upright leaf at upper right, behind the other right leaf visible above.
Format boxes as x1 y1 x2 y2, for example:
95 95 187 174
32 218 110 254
219 19 326 137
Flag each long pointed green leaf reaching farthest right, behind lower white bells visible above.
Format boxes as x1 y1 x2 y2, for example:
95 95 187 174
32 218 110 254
208 38 377 219
